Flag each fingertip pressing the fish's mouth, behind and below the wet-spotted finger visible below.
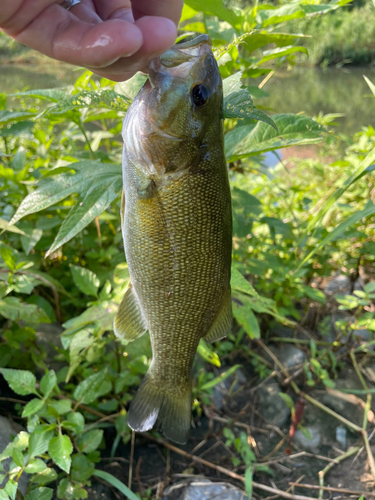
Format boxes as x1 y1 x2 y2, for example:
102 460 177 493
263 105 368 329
86 17 176 77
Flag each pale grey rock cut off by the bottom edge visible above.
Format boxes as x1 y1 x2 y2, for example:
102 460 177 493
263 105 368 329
162 478 247 500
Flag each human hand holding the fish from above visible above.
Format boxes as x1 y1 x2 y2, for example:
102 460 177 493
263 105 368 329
0 0 183 81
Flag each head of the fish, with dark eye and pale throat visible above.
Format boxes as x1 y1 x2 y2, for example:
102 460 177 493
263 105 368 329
124 35 223 175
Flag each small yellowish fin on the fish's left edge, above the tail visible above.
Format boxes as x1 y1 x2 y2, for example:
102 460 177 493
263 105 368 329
113 285 148 342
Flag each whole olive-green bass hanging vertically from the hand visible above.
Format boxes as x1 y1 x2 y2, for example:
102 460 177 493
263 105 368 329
114 35 232 444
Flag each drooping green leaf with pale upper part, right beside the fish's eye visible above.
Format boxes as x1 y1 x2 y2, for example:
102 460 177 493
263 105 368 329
223 72 277 130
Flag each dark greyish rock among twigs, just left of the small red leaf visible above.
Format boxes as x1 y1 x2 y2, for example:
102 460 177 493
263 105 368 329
257 383 290 428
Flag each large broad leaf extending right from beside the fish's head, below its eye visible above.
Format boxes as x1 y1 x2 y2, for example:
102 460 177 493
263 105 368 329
225 114 325 161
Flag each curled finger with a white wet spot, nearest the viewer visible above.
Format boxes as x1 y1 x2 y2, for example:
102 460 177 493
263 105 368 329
8 2 143 68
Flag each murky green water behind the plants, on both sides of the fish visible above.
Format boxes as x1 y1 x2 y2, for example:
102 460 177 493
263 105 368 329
0 62 375 134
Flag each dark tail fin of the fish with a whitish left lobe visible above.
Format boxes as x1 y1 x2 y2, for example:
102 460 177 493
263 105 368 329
128 372 191 444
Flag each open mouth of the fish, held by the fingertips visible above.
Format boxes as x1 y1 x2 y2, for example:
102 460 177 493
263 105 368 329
148 34 212 82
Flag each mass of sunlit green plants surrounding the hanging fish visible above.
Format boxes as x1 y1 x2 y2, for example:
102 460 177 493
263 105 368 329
0 0 375 500
